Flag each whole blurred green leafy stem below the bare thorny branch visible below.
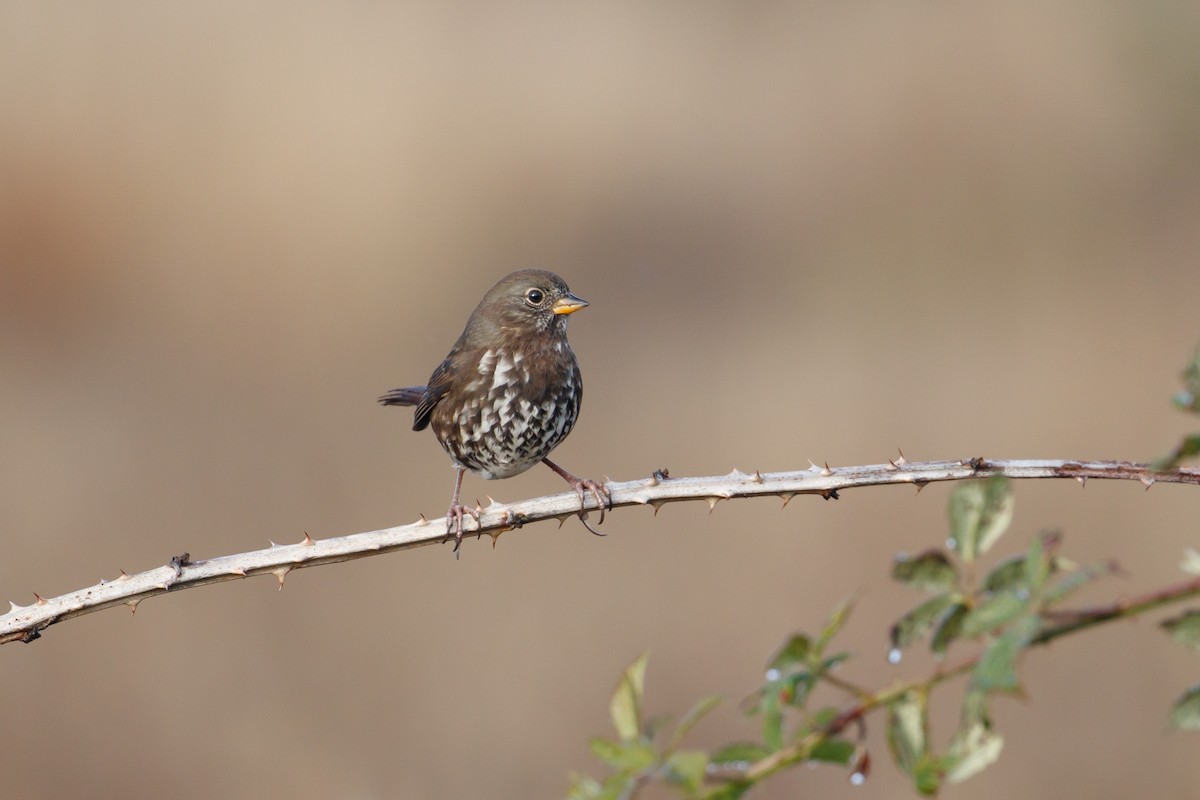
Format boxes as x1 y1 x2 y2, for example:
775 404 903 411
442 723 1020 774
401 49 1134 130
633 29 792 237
568 465 1200 800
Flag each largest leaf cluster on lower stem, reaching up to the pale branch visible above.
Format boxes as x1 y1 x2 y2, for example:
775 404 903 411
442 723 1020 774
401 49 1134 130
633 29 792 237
887 476 1111 795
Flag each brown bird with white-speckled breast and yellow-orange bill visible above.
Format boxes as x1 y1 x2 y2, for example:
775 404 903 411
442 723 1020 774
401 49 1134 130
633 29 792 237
379 270 612 558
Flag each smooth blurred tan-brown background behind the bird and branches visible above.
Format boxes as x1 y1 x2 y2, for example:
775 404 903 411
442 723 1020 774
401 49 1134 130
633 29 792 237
0 0 1200 800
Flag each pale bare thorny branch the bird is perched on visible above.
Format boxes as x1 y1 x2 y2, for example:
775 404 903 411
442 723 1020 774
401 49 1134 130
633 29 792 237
0 456 1200 644
